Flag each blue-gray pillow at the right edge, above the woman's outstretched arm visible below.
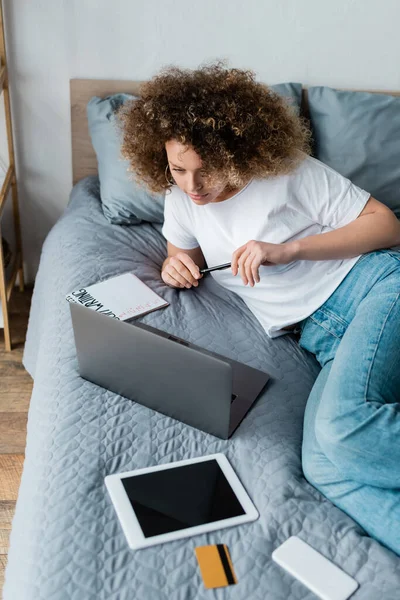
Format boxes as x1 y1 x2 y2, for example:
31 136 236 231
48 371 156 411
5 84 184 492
308 87 400 218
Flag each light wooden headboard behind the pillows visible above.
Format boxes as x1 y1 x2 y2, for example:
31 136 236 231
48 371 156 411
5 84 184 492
70 79 400 185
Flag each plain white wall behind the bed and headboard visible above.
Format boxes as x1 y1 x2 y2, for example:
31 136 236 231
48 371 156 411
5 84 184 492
3 0 400 280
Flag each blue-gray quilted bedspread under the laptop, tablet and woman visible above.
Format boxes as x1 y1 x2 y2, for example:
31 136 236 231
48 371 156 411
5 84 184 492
4 178 400 600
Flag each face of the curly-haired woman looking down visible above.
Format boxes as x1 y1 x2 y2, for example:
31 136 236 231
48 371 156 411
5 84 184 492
165 140 226 205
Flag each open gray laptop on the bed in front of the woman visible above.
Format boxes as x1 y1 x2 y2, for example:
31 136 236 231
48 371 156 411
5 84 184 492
70 303 270 439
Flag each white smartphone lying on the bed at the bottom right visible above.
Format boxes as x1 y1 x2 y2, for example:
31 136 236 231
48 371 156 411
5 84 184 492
272 536 358 600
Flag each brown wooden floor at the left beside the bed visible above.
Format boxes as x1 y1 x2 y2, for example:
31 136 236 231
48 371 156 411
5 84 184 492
0 288 33 596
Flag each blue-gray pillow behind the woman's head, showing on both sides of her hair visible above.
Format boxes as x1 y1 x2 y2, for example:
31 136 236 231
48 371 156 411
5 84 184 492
87 83 301 225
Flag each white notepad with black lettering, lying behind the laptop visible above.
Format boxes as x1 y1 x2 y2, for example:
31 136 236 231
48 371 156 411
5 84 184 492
66 272 169 321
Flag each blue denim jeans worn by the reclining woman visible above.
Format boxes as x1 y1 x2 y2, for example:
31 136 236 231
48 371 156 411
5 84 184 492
299 250 400 555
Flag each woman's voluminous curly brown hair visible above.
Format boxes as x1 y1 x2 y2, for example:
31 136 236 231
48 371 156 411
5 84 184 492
119 61 310 192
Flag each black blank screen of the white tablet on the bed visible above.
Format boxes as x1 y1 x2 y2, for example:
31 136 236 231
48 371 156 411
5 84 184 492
121 459 245 538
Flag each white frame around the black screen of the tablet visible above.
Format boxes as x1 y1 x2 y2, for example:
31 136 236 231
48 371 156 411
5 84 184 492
104 453 259 550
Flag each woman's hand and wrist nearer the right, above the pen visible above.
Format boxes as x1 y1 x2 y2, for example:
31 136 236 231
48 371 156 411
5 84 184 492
231 240 296 287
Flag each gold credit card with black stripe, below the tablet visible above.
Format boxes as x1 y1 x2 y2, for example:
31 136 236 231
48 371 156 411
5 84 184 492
195 544 237 589
